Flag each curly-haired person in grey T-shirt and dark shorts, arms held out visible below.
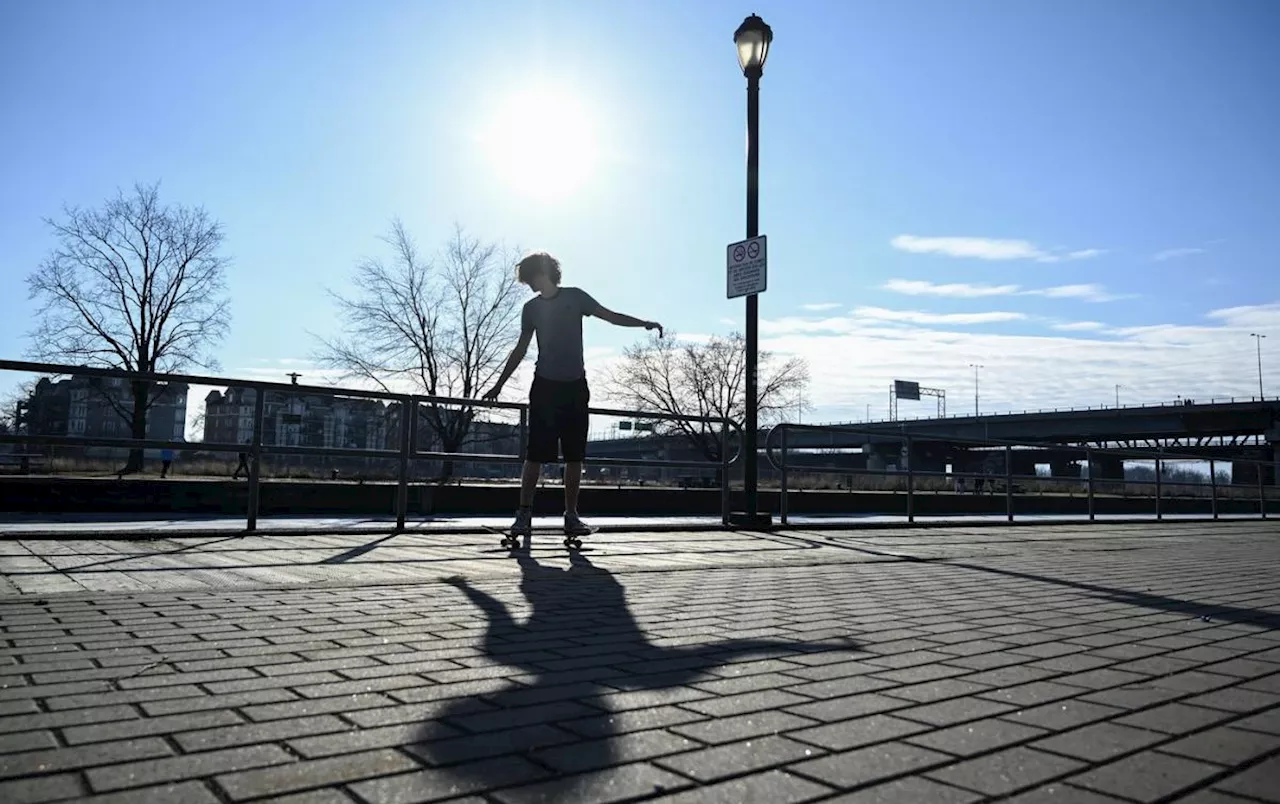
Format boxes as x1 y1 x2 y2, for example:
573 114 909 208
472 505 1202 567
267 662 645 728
484 252 662 536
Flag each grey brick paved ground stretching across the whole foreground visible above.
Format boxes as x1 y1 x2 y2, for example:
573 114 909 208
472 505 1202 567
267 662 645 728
0 522 1280 804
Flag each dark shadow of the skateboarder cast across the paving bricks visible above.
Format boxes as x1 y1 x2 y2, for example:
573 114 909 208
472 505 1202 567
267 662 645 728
412 552 858 801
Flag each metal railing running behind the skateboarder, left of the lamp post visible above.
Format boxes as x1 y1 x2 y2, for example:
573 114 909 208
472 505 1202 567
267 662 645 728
0 360 741 531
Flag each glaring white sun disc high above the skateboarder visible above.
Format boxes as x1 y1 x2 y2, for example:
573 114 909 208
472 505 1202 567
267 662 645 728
484 88 598 201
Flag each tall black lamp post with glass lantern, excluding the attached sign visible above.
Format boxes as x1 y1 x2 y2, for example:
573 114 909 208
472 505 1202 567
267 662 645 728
733 14 773 527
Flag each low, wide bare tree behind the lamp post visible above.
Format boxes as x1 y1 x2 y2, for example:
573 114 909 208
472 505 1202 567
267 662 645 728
605 333 809 461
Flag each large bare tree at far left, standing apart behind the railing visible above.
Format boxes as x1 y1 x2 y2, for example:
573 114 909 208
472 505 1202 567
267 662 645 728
27 183 230 472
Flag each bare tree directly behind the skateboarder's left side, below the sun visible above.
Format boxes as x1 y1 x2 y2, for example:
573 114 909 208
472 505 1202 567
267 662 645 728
317 220 521 480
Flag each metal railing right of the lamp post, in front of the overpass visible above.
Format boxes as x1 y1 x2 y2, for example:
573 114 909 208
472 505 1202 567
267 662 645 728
764 424 1280 525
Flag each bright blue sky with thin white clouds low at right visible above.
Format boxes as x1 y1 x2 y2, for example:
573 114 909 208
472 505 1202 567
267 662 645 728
0 0 1280 432
